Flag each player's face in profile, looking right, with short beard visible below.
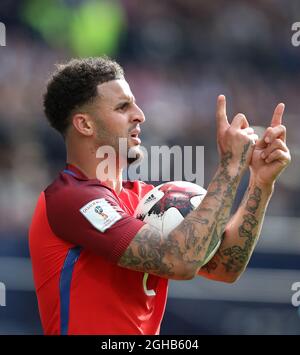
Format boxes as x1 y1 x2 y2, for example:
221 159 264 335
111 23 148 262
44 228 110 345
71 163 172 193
94 79 145 162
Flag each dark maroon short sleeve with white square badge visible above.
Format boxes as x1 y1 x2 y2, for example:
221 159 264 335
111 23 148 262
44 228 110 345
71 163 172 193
45 185 144 263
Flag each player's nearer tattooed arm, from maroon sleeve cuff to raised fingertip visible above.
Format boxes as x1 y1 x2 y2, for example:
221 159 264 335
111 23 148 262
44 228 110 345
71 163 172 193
119 96 257 279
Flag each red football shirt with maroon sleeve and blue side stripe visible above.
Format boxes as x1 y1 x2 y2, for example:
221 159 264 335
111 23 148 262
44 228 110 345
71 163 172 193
29 165 168 334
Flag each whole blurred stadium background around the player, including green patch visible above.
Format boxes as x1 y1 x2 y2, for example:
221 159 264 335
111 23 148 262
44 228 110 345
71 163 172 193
0 0 300 334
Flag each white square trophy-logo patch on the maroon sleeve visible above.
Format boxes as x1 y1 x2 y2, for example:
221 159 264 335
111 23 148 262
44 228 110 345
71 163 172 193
80 198 122 232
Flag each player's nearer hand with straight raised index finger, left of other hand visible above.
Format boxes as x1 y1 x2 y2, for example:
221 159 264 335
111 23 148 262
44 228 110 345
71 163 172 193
216 95 258 176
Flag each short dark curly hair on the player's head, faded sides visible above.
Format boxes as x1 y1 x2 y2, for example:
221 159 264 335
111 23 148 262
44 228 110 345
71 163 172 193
43 56 124 137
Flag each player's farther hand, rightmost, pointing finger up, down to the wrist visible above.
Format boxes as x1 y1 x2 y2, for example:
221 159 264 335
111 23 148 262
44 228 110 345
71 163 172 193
250 103 291 185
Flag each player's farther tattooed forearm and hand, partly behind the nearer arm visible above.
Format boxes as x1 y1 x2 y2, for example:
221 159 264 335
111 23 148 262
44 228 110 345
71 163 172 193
199 104 291 282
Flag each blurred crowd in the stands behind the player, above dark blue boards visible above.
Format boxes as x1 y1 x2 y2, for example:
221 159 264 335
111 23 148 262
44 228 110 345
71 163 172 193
0 0 300 249
